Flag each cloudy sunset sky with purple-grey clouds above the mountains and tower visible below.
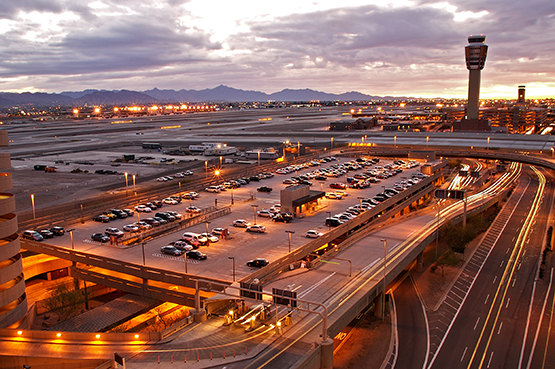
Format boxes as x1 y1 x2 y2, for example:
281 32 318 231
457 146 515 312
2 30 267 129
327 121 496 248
0 0 555 98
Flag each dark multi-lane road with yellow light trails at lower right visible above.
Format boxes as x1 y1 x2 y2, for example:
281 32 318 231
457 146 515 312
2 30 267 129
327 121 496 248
428 167 553 368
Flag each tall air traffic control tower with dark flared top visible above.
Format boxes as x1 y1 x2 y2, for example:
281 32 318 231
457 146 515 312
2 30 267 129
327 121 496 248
464 35 488 119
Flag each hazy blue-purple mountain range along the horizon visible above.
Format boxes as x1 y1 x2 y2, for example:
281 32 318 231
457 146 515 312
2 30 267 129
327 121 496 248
0 85 398 108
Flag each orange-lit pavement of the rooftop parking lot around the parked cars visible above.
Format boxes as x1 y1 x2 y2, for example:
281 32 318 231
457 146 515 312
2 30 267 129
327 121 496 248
40 158 426 281
